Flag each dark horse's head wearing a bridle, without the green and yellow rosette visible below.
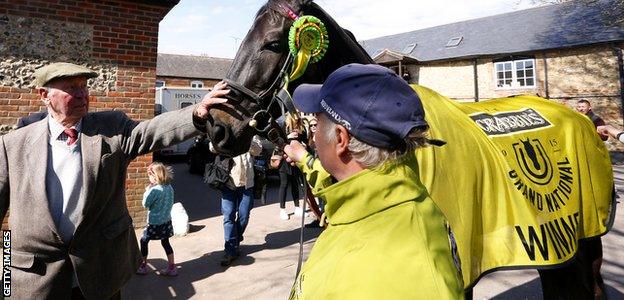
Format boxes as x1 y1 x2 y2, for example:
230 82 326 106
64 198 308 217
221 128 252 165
206 0 373 156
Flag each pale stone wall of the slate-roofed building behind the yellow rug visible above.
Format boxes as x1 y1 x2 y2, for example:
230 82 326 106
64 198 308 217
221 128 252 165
418 44 624 151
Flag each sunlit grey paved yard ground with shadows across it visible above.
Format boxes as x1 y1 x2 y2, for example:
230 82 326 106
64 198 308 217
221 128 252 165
122 164 624 299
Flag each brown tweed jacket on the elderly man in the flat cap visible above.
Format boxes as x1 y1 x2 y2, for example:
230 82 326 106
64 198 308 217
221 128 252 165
0 106 199 299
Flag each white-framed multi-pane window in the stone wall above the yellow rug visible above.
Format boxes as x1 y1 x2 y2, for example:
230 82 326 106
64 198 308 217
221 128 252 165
494 58 535 89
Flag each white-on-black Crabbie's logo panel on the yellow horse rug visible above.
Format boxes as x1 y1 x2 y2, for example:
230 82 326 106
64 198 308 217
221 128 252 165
470 108 551 136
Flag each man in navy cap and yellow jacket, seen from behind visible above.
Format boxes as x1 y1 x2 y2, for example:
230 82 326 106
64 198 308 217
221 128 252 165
284 64 463 299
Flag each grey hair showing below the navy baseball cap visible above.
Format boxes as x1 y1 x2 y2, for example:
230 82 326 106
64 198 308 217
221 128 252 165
325 116 429 169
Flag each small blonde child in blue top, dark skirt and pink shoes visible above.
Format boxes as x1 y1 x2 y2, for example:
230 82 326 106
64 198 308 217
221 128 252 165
137 162 178 276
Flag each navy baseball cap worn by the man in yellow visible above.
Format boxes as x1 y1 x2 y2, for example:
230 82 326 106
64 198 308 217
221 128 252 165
293 64 427 150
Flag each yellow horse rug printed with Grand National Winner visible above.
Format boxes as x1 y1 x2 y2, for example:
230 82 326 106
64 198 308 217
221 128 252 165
413 85 615 287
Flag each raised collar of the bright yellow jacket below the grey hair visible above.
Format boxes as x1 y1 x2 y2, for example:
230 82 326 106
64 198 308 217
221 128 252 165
317 153 428 225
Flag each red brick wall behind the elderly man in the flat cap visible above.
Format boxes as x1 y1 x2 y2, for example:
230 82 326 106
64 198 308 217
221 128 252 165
0 0 178 226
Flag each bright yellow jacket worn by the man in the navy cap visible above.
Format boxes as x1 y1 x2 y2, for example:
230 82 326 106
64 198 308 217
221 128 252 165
290 154 463 299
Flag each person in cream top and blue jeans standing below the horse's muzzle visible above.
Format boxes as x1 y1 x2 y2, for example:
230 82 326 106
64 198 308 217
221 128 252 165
220 136 262 267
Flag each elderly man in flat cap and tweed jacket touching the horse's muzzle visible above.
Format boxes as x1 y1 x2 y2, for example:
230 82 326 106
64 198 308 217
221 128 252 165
0 63 228 299
